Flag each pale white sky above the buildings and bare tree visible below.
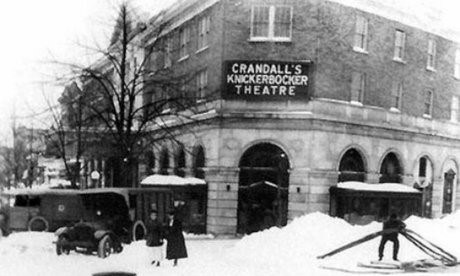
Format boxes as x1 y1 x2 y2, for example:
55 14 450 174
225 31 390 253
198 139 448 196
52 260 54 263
0 0 460 144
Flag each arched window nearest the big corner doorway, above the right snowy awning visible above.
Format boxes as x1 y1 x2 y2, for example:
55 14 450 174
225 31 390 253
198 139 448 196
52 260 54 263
338 149 366 182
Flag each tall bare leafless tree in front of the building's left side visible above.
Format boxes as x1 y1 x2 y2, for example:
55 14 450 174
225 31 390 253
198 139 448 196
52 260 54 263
56 3 212 186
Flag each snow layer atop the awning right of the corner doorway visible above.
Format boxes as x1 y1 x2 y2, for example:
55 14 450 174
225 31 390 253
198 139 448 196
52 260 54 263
337 181 420 193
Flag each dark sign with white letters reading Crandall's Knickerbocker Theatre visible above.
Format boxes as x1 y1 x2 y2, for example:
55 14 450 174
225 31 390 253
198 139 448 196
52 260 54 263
223 60 310 100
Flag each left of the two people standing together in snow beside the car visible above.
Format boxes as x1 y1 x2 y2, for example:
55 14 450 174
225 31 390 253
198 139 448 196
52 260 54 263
145 210 163 266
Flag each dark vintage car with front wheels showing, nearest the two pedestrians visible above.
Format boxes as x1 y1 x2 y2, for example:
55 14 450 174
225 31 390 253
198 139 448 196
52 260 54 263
55 188 173 258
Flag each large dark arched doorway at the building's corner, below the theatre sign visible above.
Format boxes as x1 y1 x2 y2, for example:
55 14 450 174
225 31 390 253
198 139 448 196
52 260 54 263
237 143 290 234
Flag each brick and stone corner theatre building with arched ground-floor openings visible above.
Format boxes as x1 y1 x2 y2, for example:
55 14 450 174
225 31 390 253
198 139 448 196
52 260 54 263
139 0 460 234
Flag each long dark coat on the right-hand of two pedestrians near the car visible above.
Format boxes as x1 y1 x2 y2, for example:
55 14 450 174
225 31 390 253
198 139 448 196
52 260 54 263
166 219 187 260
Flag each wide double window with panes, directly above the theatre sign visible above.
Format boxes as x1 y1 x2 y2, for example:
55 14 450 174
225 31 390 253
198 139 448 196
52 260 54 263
251 6 292 41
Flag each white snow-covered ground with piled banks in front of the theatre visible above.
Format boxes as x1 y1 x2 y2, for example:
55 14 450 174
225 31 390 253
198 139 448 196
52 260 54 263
0 212 460 276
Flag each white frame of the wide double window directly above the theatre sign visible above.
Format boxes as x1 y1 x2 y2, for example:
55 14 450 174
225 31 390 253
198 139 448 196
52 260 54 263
250 5 293 42
